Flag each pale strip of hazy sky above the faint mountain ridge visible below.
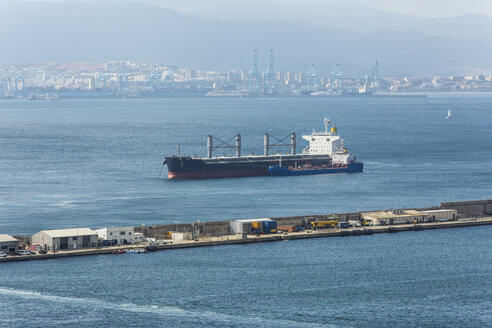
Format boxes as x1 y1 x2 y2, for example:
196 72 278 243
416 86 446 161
140 0 492 17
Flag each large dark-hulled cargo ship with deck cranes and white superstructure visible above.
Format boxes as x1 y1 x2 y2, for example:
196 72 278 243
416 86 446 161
163 119 363 179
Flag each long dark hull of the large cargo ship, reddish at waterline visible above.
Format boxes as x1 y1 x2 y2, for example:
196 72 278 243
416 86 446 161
164 155 331 179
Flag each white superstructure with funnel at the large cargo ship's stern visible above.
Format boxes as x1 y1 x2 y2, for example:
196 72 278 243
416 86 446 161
302 118 355 164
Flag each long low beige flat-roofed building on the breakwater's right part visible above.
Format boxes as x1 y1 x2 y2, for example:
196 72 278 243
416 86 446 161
361 210 426 225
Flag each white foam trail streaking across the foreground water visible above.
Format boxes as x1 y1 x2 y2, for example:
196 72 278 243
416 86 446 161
0 287 342 328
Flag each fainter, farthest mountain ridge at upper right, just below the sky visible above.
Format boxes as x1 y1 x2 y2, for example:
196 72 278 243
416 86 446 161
183 0 492 40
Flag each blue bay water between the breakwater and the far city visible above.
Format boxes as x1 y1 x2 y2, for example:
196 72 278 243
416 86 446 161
0 94 492 234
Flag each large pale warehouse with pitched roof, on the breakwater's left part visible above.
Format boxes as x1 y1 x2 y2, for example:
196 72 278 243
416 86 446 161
32 228 98 250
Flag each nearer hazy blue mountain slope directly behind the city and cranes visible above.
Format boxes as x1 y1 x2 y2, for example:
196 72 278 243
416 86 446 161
0 0 492 75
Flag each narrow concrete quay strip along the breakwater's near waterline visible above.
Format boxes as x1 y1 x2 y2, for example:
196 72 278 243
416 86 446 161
0 217 492 263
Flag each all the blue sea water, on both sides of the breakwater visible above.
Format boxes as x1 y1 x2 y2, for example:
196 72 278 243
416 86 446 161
0 94 492 327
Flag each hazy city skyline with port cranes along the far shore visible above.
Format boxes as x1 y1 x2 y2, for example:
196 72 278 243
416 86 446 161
0 57 492 99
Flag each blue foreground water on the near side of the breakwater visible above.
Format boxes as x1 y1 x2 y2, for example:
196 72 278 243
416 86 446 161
0 226 492 328
